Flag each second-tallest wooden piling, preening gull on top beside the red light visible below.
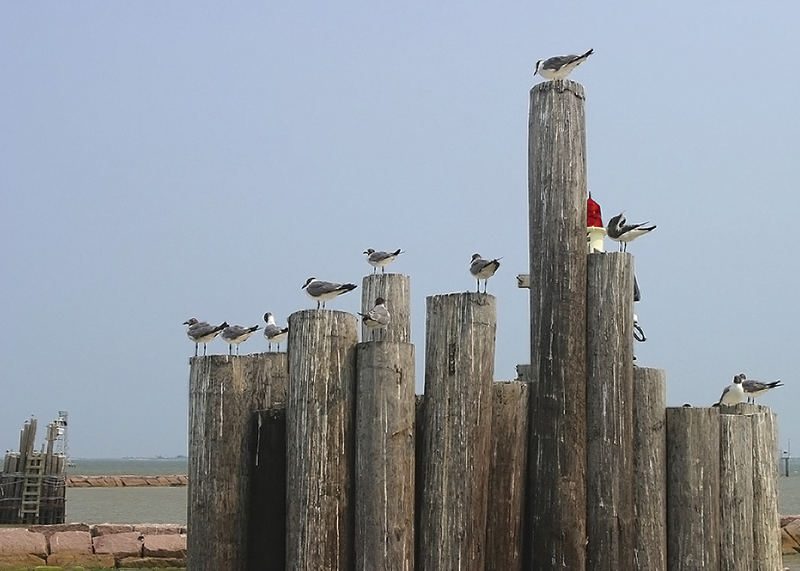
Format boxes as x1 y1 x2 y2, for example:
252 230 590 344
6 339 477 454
586 253 636 570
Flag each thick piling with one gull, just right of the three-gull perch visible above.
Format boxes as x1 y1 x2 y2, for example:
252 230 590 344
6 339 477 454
286 310 358 571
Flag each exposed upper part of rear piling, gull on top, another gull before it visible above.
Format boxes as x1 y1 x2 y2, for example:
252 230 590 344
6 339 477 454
361 274 411 343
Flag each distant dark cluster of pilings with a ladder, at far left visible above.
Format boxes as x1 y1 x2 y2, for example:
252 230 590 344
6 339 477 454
0 418 67 524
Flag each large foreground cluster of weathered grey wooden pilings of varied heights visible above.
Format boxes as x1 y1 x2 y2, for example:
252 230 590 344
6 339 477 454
188 81 780 571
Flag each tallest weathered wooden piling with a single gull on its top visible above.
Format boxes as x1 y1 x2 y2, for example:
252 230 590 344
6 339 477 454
526 80 586 569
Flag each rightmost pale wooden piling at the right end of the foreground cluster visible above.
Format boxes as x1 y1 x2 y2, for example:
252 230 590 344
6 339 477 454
750 406 783 570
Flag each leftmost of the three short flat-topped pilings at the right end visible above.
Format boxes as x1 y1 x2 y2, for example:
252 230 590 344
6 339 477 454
667 407 721 571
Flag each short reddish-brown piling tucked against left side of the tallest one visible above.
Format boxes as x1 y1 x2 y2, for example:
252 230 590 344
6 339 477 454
486 381 529 571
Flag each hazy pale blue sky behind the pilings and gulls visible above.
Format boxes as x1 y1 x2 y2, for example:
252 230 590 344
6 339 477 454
0 0 800 457
